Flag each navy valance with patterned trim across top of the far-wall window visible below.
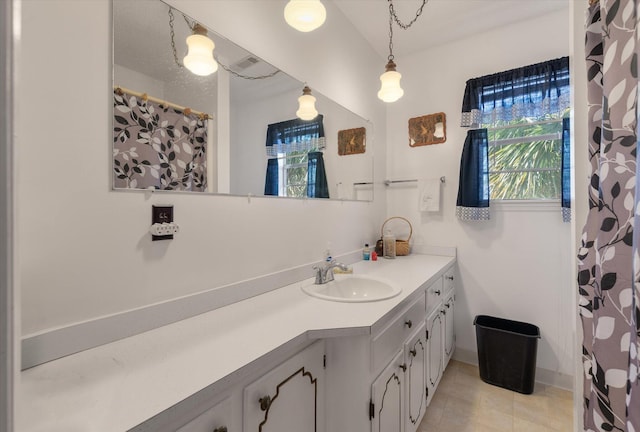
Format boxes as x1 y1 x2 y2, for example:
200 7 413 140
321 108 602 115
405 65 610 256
461 57 571 128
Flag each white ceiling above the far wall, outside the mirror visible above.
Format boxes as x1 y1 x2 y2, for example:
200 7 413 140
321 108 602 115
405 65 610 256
333 0 569 58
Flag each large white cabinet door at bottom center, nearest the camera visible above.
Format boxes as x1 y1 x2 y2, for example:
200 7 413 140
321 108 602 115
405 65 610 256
243 341 325 432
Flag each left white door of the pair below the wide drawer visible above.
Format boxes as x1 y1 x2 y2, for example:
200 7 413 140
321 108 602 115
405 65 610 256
369 351 406 432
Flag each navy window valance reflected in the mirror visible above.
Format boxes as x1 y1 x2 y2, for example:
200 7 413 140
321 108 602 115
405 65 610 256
266 114 326 157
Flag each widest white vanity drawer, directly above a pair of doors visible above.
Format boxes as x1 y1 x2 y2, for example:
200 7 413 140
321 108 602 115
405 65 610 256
371 294 426 373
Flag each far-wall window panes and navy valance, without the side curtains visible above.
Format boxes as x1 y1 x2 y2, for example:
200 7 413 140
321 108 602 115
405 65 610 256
463 57 570 200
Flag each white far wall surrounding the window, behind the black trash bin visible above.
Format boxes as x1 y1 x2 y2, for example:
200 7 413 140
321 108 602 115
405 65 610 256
387 6 575 382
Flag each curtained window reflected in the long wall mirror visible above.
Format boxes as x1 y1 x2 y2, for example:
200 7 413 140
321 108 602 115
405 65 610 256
265 115 329 198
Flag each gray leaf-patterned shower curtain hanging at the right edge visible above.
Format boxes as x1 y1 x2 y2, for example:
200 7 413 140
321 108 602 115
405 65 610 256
578 0 640 432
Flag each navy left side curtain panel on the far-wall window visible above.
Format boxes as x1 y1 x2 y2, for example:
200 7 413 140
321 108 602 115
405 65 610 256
456 129 490 221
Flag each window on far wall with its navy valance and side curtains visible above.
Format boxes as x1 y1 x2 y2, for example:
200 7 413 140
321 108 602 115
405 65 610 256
456 57 571 222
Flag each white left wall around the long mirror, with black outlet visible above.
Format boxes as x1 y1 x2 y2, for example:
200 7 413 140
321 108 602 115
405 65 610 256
16 0 385 334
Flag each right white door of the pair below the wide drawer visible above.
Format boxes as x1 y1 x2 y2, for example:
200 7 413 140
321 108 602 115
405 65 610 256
404 322 427 432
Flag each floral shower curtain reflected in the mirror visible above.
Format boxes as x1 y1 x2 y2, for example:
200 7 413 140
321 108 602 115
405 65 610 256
113 90 207 192
